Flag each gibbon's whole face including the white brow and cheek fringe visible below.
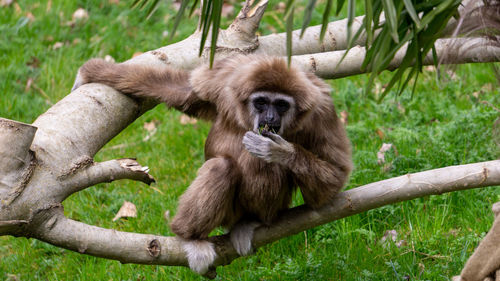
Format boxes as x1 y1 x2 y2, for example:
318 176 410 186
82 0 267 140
248 91 296 135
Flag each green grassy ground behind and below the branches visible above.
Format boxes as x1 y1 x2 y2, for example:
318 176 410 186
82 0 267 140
0 0 500 280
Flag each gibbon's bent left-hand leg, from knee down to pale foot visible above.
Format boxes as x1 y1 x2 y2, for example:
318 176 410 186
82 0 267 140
171 158 239 274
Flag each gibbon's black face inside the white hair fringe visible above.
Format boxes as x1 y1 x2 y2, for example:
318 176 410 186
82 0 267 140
251 92 293 133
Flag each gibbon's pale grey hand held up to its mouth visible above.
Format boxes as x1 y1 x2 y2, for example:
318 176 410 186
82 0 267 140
243 131 295 164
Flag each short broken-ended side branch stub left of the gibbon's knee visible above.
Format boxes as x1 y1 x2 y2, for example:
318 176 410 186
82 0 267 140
58 158 155 202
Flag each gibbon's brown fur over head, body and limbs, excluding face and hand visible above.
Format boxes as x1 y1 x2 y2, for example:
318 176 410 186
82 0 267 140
80 56 352 239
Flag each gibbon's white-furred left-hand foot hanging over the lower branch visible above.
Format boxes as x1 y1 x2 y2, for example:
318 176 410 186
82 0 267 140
182 240 217 274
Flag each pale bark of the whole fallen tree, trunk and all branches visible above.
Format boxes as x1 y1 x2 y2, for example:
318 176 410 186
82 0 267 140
0 0 500 276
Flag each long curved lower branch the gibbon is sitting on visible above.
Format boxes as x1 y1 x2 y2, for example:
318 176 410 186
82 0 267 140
28 160 500 266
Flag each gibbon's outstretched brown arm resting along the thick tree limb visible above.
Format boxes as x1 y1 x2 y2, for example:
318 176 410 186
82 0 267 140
73 59 216 120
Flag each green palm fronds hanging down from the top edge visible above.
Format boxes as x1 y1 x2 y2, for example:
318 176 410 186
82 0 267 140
132 0 461 98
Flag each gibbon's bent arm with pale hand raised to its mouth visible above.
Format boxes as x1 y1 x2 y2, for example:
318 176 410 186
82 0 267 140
243 132 352 208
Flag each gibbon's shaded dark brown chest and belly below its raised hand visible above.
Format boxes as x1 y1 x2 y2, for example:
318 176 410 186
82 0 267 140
237 154 293 223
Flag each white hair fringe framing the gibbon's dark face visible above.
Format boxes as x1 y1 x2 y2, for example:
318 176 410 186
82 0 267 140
247 92 296 135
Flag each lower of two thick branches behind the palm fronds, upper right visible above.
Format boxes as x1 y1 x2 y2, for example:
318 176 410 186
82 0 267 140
292 38 500 79
